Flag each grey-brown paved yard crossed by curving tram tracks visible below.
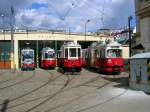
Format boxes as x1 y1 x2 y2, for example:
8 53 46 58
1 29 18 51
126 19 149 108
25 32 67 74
0 69 150 112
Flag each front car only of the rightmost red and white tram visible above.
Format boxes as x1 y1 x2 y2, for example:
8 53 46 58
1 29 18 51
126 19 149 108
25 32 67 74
94 42 123 72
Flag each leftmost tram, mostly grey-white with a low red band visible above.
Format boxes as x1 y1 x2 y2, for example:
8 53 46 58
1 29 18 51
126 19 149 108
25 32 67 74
21 48 35 70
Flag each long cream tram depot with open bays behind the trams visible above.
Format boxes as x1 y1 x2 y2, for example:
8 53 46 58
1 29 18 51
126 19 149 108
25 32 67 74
0 30 114 69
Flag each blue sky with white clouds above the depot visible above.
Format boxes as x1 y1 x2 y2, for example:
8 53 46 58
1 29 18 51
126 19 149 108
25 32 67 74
0 0 135 32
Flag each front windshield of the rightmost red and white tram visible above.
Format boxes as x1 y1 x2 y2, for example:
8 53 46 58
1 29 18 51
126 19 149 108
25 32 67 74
107 49 122 58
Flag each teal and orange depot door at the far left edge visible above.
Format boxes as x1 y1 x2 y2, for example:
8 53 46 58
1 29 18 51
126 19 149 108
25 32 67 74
0 41 11 69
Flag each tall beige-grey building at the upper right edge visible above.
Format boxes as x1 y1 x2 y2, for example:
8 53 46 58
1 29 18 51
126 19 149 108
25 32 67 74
132 0 150 54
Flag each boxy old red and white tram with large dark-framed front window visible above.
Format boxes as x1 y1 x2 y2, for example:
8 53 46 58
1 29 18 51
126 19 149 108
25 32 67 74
57 42 82 72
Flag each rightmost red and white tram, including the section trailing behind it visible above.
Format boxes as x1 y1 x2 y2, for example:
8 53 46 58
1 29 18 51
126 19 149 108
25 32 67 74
87 42 123 72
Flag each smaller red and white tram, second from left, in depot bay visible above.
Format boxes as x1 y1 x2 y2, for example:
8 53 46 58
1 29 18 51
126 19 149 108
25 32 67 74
40 47 56 69
